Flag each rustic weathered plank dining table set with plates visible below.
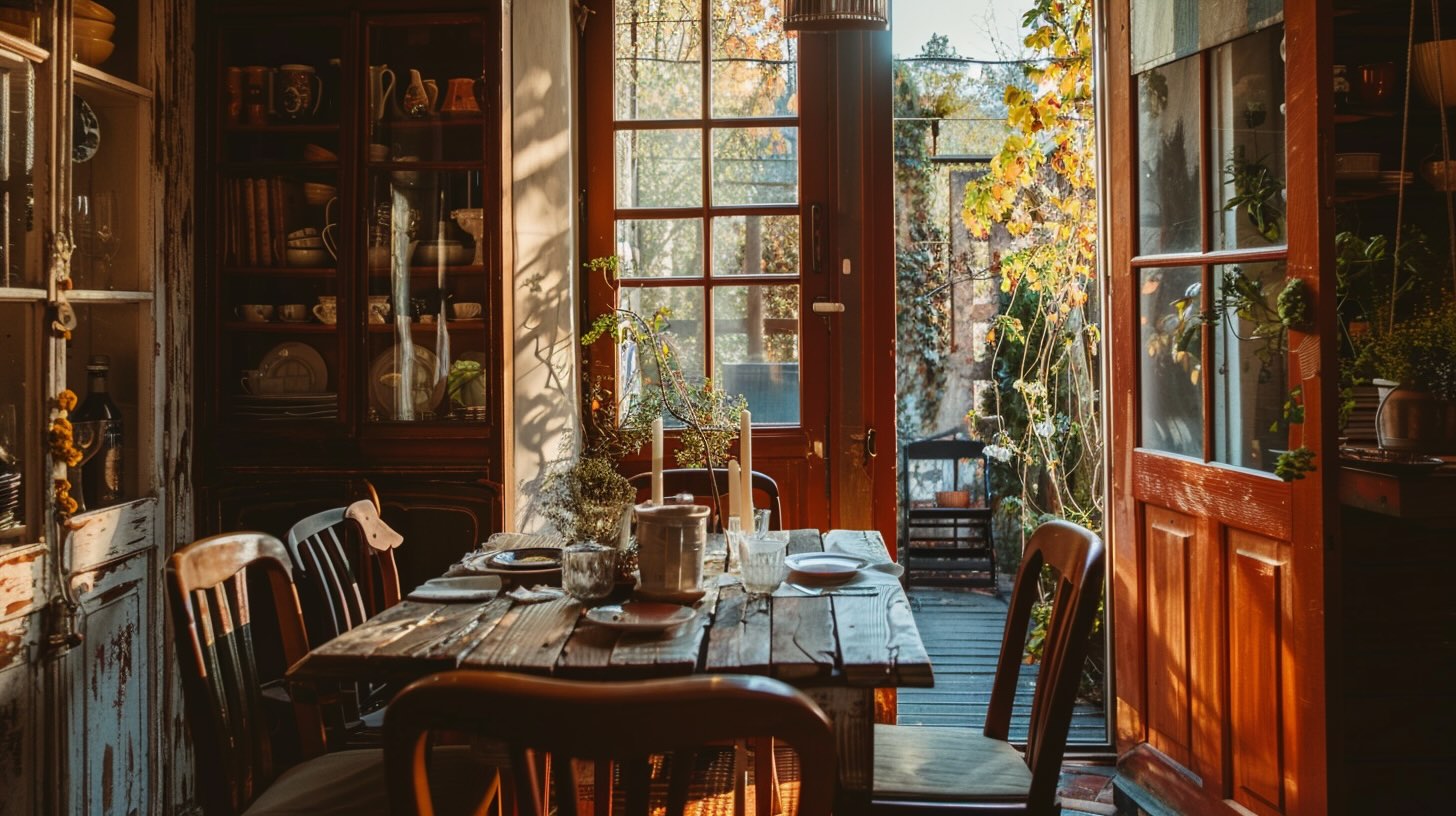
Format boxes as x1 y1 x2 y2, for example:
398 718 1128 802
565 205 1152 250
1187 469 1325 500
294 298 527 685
288 530 933 810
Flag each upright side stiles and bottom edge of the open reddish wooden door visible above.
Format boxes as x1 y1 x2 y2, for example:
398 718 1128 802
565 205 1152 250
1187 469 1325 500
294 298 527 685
1098 0 1338 813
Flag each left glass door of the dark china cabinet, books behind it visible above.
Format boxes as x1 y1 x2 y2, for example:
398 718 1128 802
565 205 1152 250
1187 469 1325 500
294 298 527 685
211 20 349 424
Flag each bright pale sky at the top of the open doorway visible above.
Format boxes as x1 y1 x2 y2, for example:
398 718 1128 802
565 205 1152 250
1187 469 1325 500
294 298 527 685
890 0 1032 60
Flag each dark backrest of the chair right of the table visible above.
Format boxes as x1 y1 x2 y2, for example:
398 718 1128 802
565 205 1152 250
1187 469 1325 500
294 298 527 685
986 520 1105 812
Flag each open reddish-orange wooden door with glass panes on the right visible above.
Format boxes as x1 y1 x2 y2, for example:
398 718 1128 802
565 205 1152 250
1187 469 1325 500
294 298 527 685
1098 0 1337 813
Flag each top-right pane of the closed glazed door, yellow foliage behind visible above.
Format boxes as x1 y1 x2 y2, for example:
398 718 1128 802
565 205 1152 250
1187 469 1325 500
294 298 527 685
712 0 798 118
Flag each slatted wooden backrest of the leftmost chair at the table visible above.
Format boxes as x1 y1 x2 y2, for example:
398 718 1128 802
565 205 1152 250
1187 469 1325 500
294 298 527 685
167 532 323 815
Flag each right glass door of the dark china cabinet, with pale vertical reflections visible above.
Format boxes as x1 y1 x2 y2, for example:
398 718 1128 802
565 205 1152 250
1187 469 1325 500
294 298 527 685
364 16 492 423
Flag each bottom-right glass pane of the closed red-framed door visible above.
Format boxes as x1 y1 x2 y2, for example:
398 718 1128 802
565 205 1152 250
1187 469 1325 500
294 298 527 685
713 286 799 424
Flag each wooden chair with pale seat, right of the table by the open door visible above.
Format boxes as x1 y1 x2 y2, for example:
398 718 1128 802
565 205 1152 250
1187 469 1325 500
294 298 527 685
874 522 1104 815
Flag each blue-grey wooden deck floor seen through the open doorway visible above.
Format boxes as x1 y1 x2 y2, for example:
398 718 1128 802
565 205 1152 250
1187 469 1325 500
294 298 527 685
898 587 1105 743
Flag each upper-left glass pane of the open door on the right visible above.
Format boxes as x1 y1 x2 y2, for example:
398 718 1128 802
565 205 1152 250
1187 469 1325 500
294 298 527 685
1137 58 1203 255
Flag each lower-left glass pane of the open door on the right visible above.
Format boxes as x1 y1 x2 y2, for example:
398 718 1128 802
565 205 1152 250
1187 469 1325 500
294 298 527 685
1139 267 1204 459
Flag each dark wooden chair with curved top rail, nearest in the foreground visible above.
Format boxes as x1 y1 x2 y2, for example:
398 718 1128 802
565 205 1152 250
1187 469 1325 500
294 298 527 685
384 670 836 816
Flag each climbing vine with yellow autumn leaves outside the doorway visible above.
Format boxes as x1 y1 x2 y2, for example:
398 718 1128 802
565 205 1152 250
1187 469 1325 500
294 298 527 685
961 0 1104 533
